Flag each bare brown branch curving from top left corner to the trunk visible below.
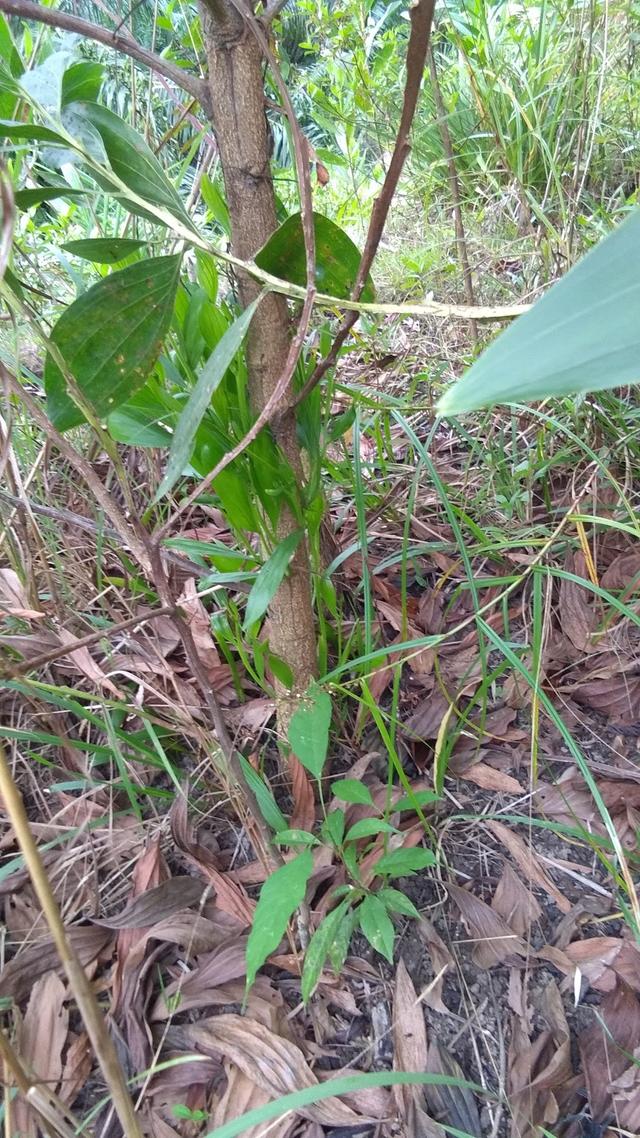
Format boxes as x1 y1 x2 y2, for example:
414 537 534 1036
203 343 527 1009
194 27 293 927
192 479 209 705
0 0 208 110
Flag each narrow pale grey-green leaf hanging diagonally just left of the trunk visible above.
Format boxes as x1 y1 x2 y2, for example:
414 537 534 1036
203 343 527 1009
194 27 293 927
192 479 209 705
154 296 261 502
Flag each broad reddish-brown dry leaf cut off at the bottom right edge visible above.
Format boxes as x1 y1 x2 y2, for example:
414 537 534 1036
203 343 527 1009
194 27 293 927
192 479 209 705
579 980 640 1133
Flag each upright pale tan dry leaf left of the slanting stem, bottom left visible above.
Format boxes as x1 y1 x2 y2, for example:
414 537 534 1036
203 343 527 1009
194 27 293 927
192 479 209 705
14 972 68 1136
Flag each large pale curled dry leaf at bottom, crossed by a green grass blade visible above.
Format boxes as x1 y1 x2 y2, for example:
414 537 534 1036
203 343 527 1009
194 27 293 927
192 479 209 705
183 1015 362 1127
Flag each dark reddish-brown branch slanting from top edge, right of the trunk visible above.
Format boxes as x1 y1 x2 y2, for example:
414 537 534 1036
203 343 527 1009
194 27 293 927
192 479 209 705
288 0 435 406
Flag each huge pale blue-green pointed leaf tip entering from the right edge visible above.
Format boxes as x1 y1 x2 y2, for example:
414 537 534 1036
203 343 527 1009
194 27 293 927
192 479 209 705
438 209 640 415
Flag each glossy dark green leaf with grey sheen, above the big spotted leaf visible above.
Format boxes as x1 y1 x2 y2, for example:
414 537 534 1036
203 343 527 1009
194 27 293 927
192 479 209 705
67 102 190 225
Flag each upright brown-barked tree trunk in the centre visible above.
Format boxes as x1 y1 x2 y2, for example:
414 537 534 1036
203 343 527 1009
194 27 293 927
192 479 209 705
200 0 317 729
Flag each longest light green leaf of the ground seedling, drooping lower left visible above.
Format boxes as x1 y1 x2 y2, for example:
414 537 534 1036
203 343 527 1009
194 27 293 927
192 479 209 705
246 850 313 990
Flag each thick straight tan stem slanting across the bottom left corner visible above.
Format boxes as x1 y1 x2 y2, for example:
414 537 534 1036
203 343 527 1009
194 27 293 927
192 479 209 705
0 748 142 1138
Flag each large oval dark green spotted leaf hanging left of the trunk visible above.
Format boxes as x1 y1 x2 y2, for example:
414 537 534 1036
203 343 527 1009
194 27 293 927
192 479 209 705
44 256 181 430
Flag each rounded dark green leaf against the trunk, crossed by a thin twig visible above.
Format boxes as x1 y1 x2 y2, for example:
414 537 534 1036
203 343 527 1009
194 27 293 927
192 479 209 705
255 213 376 303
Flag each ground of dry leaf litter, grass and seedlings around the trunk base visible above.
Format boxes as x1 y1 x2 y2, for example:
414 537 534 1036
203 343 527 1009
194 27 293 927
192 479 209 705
0 336 640 1138
